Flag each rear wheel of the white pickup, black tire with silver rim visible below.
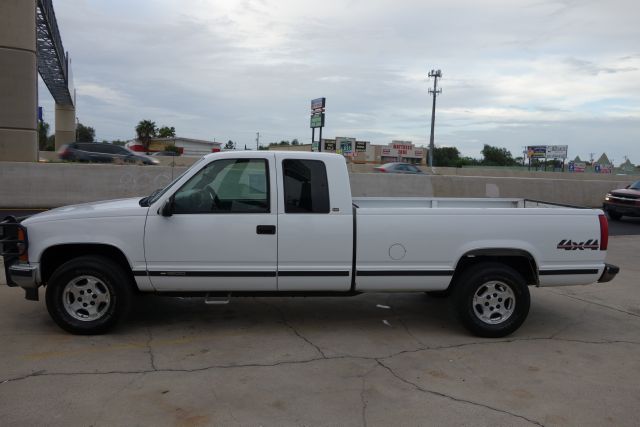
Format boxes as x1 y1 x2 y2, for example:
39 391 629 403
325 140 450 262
453 262 530 338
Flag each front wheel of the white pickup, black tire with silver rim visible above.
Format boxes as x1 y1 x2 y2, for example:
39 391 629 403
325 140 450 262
46 256 134 335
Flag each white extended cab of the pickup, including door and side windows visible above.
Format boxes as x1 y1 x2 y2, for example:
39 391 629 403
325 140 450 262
136 151 353 291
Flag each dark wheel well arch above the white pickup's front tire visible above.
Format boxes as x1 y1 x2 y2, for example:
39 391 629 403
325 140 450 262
40 243 134 284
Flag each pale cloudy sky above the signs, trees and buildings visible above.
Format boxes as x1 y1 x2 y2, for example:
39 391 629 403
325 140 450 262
40 0 640 163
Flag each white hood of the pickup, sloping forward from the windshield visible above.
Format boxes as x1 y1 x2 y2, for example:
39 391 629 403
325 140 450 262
22 197 149 226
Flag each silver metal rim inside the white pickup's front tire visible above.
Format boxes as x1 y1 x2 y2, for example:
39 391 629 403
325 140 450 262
62 276 111 322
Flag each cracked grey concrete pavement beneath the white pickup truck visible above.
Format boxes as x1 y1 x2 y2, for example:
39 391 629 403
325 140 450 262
0 236 640 426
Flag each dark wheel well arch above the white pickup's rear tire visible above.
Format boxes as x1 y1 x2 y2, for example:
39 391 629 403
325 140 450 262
449 249 539 287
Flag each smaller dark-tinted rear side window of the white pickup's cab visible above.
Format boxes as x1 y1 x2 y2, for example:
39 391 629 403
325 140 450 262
282 159 329 213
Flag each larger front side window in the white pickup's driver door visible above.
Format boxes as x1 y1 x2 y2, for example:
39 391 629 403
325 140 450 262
173 159 270 214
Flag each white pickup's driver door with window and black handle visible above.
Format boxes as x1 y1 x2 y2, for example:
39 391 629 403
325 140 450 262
144 153 277 291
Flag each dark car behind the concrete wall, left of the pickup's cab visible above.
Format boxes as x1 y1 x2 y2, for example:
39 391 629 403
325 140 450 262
58 142 160 165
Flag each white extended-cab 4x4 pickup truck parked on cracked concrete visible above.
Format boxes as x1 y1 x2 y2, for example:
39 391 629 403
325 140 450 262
1 151 619 337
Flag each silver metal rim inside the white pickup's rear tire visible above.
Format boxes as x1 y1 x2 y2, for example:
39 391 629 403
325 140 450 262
473 280 516 325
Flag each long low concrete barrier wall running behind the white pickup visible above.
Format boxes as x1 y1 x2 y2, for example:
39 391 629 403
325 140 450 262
0 162 629 208
